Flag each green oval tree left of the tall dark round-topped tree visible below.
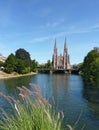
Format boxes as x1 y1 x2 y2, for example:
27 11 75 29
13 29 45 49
5 53 16 73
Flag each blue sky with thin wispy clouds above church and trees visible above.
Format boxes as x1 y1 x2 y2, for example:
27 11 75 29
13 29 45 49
0 0 99 64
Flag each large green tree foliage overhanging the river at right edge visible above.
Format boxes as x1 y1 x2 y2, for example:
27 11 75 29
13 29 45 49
82 48 99 87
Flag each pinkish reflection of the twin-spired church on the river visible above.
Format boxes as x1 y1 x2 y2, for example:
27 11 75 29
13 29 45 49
53 75 69 109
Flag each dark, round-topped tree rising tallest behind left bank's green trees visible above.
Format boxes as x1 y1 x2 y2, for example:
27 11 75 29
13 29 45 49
15 48 31 67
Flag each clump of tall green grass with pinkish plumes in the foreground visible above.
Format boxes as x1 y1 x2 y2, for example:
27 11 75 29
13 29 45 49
0 84 73 130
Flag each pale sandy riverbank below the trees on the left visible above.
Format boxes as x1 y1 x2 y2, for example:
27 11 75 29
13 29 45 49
0 71 37 79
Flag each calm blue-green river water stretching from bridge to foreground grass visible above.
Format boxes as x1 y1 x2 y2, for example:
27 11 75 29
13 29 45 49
0 74 99 130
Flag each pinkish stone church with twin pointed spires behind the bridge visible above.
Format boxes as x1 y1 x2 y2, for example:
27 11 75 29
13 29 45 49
52 39 71 70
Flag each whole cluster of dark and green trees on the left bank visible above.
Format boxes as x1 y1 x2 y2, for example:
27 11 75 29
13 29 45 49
1 48 38 74
